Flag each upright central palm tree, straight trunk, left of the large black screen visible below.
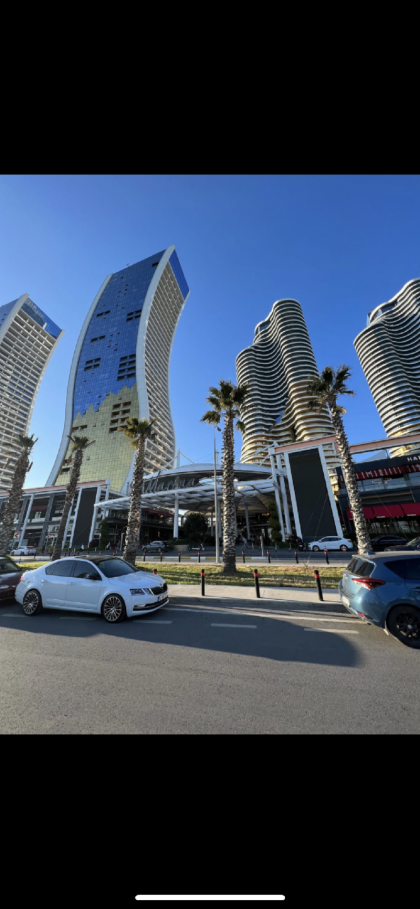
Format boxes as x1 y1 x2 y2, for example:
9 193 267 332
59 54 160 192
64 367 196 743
201 379 248 574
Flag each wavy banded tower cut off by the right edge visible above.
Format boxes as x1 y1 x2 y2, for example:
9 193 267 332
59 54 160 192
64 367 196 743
354 278 420 457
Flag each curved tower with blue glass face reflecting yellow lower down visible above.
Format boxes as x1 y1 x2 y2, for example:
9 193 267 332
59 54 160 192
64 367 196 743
47 246 189 492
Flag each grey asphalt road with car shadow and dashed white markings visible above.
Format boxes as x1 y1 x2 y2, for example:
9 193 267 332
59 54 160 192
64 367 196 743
0 600 420 734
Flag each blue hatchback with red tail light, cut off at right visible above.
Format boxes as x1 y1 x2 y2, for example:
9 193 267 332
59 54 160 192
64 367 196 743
338 550 420 649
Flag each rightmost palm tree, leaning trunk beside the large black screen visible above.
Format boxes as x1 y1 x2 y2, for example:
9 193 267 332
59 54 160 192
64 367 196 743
308 365 370 552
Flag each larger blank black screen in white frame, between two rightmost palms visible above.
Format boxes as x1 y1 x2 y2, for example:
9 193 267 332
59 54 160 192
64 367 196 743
289 448 337 542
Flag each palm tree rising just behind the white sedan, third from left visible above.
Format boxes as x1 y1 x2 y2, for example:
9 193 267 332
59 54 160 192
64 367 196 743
120 417 156 565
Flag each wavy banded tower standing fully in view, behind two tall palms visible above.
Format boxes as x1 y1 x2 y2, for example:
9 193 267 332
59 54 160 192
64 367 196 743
236 299 339 482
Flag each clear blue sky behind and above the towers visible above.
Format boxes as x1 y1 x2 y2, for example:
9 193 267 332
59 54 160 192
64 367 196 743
0 176 420 486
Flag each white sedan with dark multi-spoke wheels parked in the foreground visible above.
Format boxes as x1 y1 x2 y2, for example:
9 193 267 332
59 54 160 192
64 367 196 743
15 556 168 622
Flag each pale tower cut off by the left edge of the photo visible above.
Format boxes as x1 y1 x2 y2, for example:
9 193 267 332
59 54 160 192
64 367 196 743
0 294 63 493
